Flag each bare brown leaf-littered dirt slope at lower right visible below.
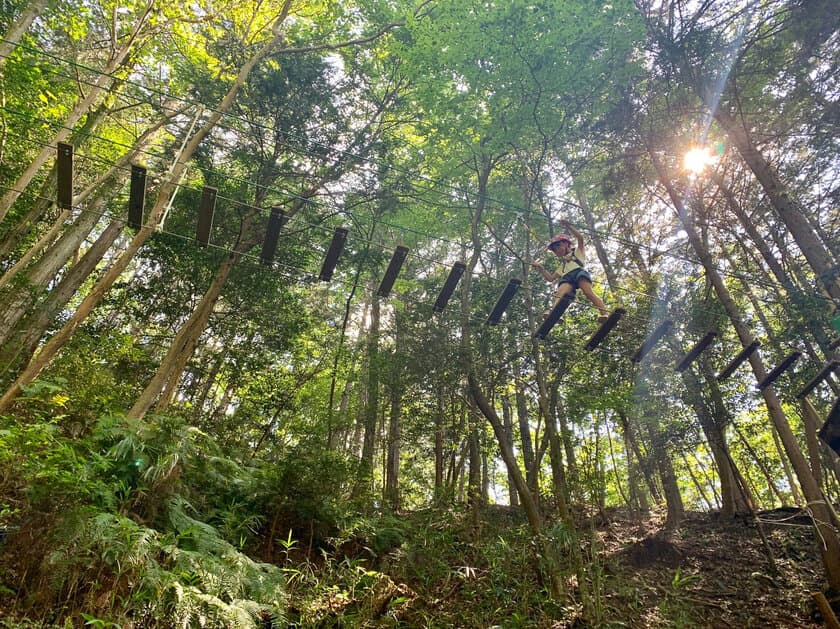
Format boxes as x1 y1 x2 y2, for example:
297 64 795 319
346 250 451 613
599 509 825 627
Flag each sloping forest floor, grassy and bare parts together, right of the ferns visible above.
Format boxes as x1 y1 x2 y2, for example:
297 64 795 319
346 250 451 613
0 506 825 629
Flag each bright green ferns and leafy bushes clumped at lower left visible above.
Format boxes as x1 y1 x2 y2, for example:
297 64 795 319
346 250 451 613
0 417 286 627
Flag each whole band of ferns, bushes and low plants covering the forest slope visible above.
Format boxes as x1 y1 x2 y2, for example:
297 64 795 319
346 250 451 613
0 400 819 629
